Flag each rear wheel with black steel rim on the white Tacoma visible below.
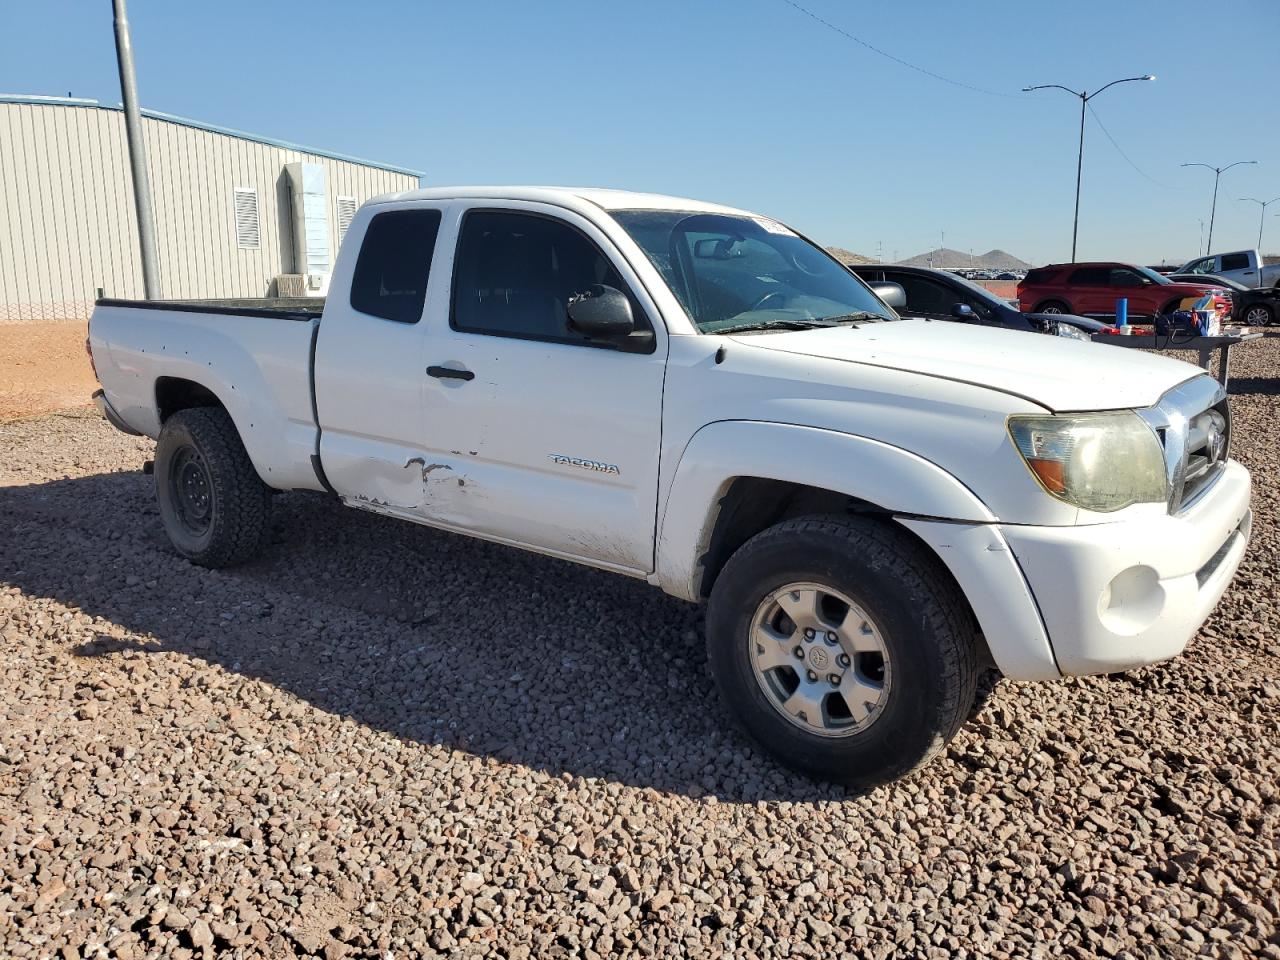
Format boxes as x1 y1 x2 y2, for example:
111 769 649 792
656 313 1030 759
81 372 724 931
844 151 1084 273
155 407 271 567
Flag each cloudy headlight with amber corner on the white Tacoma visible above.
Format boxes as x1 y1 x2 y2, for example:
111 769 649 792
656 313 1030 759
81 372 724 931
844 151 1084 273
1009 410 1167 513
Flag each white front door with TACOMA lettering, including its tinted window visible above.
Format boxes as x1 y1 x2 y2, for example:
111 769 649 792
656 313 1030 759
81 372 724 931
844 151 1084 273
421 202 667 572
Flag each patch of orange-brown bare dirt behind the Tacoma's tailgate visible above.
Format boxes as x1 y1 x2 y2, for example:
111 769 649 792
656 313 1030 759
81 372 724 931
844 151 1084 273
0 320 97 421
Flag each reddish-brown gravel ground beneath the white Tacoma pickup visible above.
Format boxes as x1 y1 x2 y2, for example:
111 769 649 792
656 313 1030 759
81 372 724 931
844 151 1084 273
0 340 1280 960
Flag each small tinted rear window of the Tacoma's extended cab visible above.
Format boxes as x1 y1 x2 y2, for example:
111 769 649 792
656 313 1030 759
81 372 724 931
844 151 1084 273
351 210 440 324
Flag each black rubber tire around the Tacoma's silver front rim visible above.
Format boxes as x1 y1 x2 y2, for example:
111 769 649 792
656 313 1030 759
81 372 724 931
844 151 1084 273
707 516 980 790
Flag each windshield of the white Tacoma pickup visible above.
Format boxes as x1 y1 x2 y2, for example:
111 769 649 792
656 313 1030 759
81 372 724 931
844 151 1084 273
613 210 897 333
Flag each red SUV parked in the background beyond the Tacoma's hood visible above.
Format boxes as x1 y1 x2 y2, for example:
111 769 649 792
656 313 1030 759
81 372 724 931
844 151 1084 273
1018 264 1231 320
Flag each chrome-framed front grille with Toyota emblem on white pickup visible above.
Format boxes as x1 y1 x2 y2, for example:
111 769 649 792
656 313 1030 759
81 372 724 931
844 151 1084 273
1140 376 1231 513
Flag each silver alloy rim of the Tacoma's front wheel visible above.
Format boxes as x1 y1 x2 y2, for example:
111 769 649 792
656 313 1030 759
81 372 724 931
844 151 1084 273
750 582 892 737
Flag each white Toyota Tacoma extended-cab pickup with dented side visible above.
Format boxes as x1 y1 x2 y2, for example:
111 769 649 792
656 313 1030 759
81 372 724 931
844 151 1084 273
90 187 1251 787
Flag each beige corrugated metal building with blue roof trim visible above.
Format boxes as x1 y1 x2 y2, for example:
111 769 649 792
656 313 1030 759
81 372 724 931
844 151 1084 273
0 95 422 323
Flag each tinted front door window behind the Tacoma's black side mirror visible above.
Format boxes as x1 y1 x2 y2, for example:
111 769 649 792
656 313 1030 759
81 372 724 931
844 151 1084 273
452 210 645 346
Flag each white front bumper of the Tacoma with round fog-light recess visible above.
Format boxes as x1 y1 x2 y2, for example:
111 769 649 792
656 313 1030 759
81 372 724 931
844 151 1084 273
901 461 1252 680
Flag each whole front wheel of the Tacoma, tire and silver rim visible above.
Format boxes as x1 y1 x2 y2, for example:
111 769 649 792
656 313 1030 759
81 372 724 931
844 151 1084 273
707 516 979 788
